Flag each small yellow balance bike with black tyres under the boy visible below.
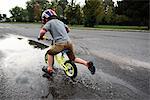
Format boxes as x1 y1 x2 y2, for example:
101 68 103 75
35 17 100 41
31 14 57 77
44 37 77 79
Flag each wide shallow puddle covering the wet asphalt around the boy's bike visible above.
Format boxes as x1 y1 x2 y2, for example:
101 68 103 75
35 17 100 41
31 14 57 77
0 23 150 100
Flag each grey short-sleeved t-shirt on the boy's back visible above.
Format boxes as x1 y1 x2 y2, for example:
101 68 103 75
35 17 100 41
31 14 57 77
43 19 70 43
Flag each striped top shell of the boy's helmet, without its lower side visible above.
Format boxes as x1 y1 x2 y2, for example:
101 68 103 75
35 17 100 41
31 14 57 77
42 9 57 19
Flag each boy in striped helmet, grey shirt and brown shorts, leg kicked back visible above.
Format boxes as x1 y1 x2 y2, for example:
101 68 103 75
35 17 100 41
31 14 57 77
38 9 95 75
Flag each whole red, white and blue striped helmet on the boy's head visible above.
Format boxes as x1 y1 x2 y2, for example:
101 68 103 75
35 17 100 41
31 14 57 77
42 9 57 24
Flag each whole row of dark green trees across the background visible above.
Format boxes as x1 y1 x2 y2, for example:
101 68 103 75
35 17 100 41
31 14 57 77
8 0 150 27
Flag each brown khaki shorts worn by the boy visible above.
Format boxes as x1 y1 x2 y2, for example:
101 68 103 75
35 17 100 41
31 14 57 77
48 41 75 60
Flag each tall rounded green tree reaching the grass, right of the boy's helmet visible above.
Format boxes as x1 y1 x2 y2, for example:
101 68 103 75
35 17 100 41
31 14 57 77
83 0 104 27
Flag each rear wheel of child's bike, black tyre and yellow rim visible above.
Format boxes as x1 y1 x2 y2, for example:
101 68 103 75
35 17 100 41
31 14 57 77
64 60 77 79
